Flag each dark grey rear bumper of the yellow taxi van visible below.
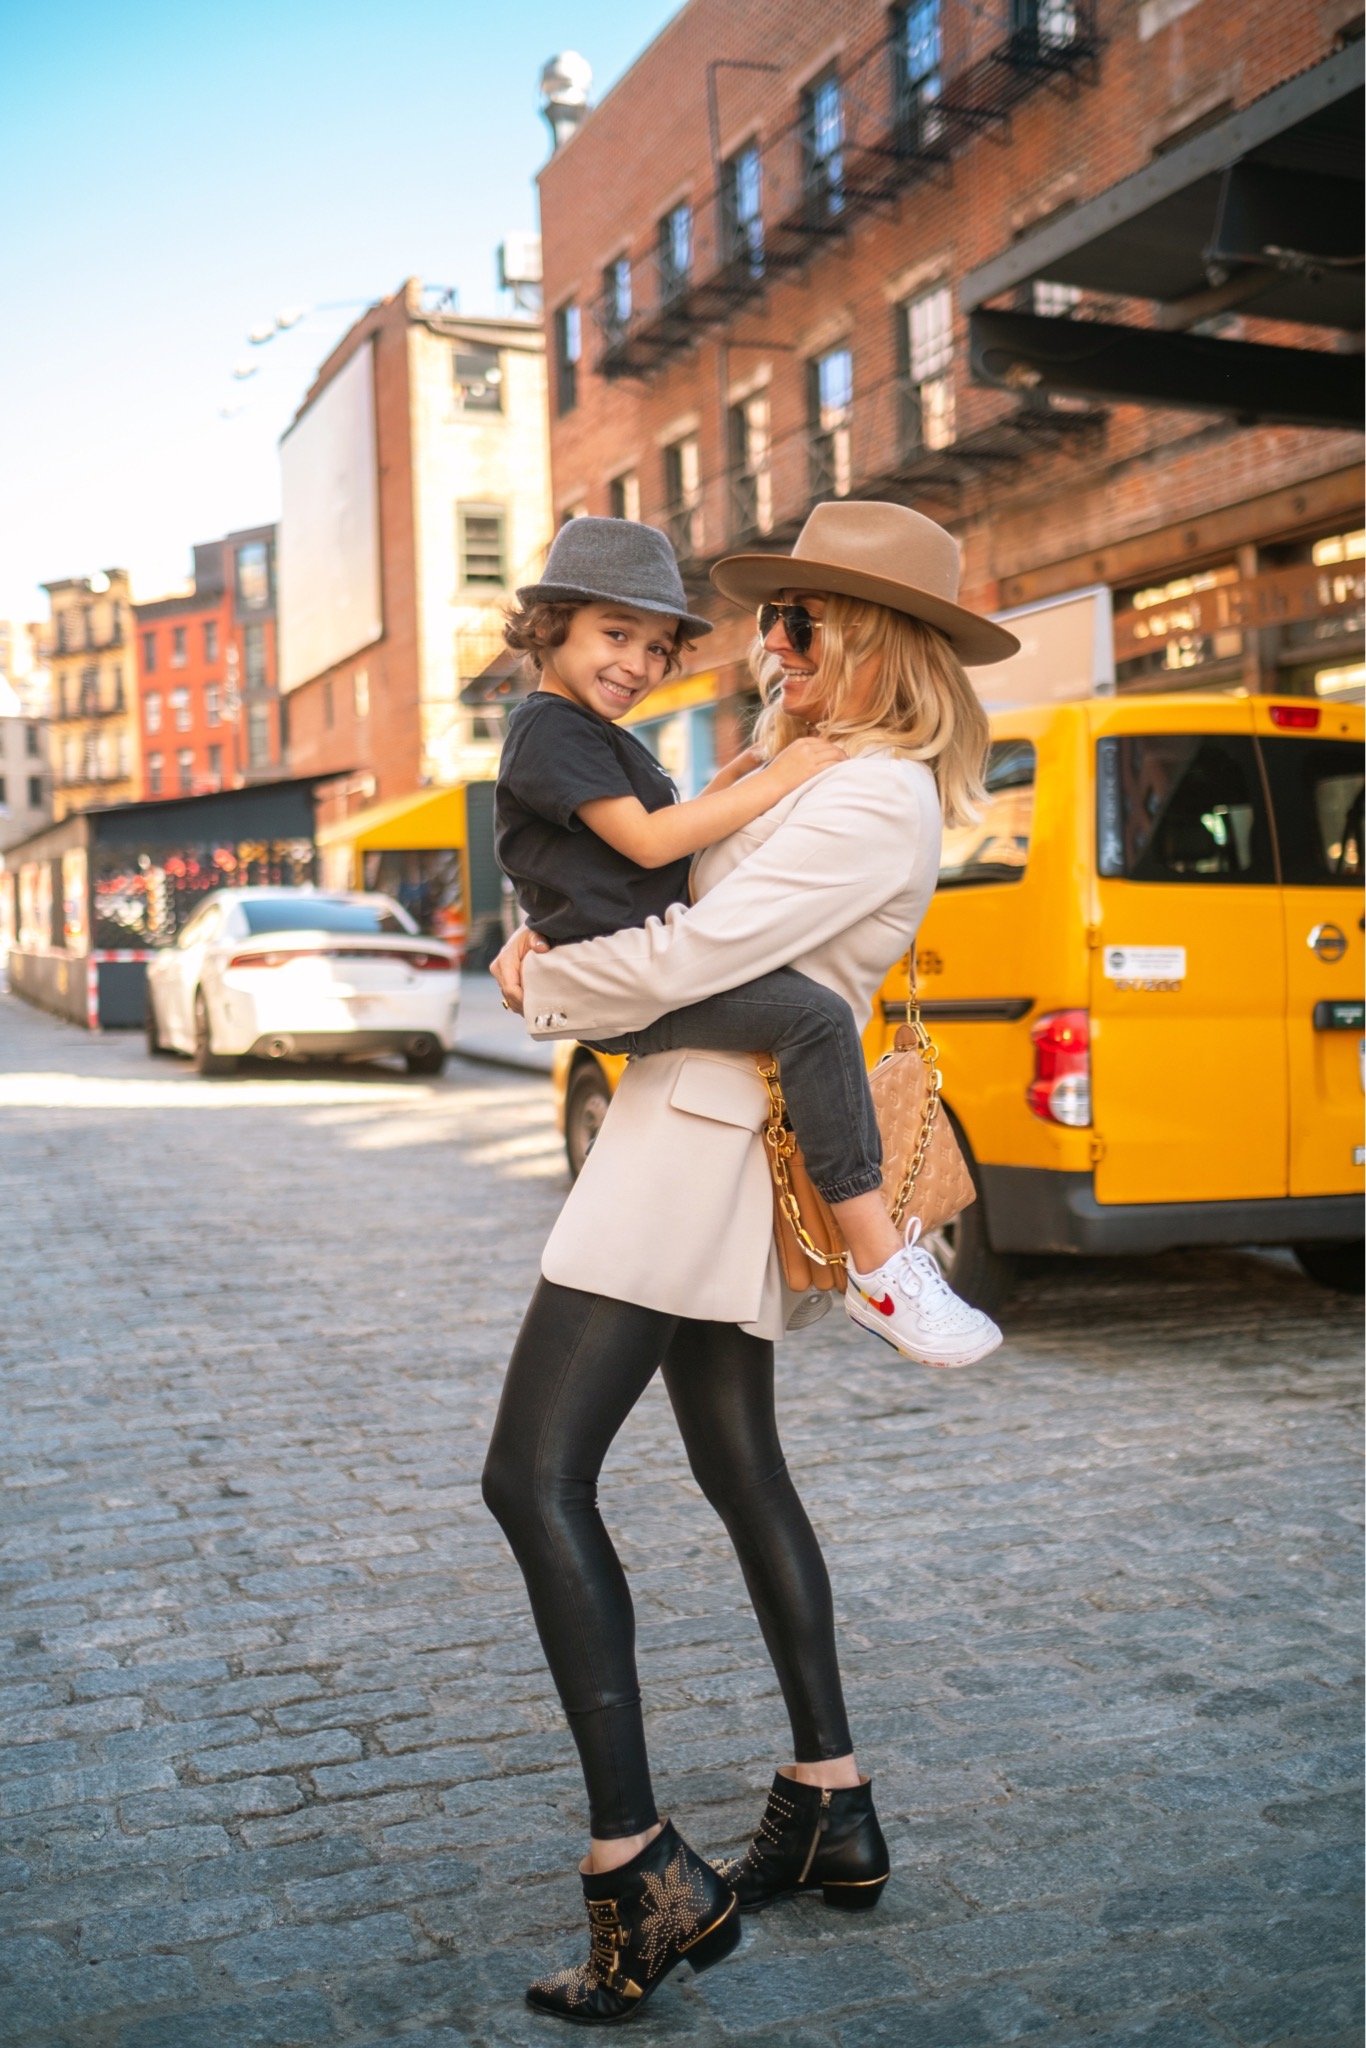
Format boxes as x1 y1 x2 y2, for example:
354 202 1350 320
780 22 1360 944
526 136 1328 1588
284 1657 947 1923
977 1165 1362 1255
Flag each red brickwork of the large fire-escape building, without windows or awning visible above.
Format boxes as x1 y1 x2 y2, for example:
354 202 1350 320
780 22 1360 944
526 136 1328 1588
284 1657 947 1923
541 0 1360 720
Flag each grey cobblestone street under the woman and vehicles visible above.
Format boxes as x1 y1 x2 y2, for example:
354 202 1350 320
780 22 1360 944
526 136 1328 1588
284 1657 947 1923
0 997 1360 2048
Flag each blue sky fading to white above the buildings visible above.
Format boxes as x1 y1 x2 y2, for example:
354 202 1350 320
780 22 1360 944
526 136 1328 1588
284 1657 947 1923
0 0 678 618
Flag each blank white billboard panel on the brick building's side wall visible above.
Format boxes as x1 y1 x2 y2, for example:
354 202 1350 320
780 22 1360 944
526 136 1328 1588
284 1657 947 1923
279 340 385 690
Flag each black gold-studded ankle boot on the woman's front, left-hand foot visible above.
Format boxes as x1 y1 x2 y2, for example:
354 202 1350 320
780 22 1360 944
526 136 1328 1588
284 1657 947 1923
526 1821 739 2025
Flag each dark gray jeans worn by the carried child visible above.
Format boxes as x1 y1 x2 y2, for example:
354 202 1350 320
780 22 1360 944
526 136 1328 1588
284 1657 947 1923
594 967 883 1202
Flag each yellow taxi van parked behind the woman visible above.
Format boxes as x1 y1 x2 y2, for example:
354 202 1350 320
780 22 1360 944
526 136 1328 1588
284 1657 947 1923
555 694 1366 1309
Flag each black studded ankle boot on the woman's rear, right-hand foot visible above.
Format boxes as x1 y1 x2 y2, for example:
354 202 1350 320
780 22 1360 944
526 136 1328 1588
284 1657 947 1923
717 1772 891 1913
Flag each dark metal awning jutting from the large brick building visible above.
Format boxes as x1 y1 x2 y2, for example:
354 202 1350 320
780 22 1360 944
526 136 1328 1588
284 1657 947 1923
961 43 1364 426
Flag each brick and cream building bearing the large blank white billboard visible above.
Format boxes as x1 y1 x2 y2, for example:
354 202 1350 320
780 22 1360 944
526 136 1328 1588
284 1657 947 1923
281 279 551 825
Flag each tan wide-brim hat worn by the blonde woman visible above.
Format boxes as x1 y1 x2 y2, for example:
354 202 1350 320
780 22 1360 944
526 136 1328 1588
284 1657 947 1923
711 498 1020 668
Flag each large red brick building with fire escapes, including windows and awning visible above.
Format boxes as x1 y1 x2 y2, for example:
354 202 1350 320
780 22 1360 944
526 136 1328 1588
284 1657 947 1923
541 0 1362 782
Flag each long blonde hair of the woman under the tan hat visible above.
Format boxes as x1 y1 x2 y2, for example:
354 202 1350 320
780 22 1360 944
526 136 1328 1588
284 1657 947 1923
750 596 991 825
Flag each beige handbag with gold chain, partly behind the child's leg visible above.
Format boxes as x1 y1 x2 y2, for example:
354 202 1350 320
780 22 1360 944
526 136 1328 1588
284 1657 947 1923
758 952 977 1292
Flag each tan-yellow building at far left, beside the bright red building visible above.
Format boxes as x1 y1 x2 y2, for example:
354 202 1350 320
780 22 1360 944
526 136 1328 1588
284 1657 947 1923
43 569 139 819
